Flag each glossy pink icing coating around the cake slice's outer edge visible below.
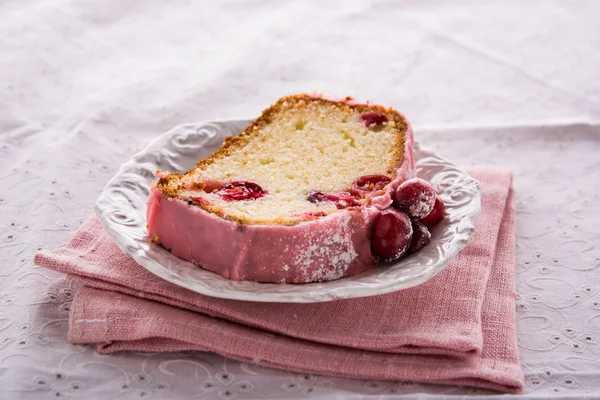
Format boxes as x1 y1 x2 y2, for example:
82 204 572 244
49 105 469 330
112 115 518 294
147 103 415 283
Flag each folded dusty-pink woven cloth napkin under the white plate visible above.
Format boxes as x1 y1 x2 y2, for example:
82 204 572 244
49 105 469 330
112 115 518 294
35 168 523 392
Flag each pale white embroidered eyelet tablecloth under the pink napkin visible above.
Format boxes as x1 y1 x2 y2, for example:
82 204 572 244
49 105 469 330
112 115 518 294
0 0 600 399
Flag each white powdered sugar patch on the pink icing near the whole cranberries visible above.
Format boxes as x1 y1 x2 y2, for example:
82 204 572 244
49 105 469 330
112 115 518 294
294 214 358 282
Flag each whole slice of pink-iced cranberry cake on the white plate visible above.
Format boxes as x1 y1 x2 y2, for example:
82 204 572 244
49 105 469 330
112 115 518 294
147 94 414 283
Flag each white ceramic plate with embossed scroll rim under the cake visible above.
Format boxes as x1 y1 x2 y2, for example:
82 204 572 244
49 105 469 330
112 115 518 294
96 120 481 303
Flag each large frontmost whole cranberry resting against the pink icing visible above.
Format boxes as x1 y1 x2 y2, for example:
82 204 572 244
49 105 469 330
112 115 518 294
371 208 413 262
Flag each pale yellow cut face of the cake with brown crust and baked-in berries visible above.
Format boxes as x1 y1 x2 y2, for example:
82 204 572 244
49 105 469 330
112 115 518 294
157 95 407 224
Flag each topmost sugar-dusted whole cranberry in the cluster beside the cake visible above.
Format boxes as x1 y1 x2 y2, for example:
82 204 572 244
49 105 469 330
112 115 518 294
394 178 436 220
